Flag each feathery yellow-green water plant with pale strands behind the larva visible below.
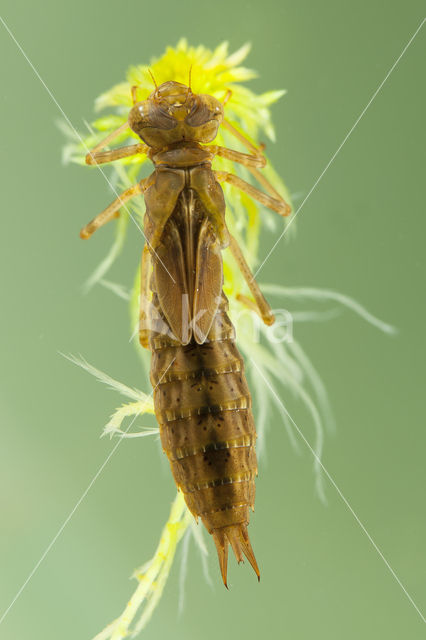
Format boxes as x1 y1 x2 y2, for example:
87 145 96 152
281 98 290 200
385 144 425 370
64 39 393 640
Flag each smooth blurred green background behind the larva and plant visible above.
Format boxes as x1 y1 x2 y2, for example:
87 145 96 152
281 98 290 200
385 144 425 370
0 0 426 640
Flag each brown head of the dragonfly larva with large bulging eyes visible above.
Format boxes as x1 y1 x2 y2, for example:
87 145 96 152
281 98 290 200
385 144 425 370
129 81 223 149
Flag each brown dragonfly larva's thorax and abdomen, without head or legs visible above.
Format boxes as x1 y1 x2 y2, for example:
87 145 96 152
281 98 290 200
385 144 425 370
145 148 257 572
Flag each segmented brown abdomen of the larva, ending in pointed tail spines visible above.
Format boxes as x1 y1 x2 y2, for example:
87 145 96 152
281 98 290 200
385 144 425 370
151 294 259 584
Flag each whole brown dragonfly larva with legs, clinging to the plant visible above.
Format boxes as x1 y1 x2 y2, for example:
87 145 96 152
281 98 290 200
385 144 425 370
80 81 290 585
